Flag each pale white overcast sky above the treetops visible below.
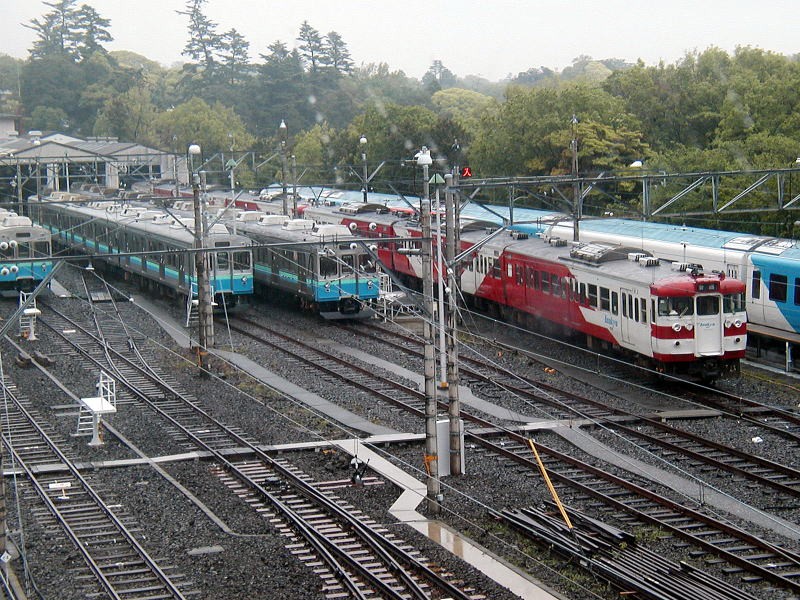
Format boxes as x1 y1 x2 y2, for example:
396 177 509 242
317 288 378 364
0 0 800 81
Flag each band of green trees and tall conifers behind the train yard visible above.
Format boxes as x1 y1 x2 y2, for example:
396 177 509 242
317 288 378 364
0 0 800 230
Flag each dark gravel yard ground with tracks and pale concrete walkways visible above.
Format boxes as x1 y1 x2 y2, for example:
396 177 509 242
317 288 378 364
0 266 800 600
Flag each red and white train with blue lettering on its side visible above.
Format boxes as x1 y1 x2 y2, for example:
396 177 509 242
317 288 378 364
304 204 747 381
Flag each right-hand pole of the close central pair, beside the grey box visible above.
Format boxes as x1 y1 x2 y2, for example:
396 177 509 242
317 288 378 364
442 173 464 475
